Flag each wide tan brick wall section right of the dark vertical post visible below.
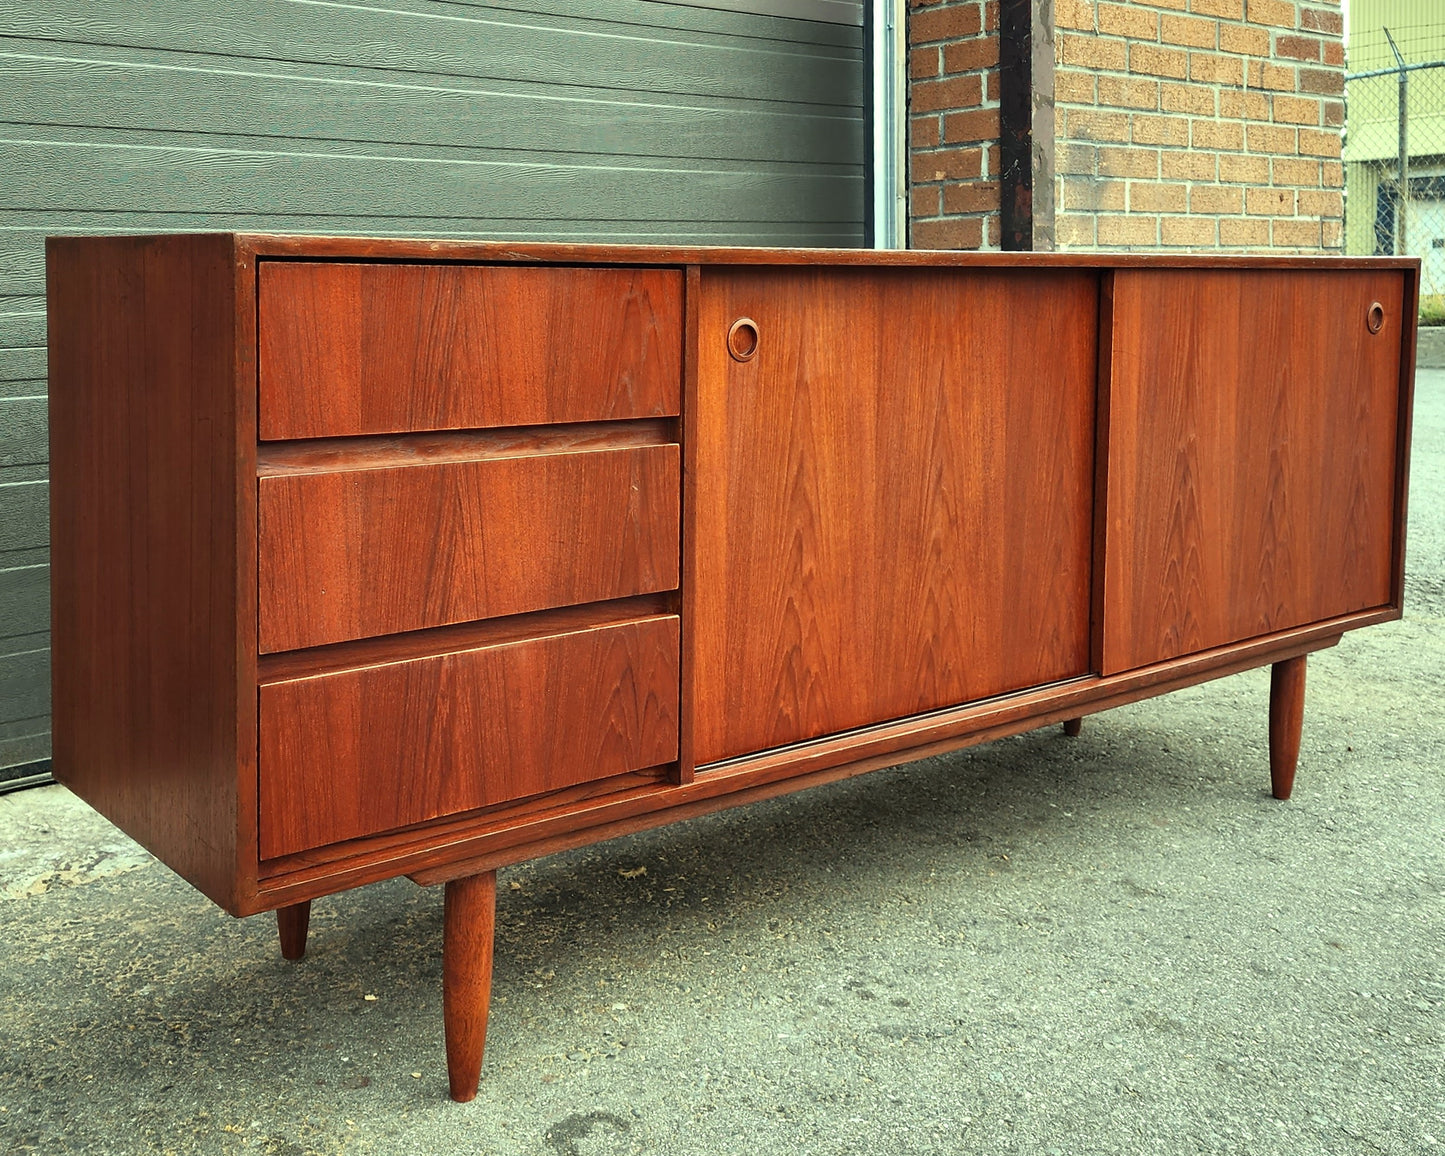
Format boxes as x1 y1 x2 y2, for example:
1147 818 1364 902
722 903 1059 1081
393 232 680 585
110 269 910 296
1055 0 1344 251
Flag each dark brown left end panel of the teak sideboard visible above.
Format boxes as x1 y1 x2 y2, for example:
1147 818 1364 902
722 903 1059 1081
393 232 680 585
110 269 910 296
48 236 238 910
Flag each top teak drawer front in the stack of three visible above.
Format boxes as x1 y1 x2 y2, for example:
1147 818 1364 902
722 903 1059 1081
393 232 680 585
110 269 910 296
259 262 682 439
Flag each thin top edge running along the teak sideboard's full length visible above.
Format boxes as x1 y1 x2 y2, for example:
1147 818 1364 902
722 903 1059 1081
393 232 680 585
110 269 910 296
49 233 1420 270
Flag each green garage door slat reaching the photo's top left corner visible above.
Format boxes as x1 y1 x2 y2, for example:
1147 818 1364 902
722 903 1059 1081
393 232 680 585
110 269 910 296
0 0 861 105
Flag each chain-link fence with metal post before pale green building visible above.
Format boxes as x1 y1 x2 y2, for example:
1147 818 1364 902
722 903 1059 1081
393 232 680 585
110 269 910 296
1344 27 1445 322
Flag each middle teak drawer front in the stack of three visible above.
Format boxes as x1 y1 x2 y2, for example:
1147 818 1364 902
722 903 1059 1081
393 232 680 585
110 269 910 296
257 445 681 653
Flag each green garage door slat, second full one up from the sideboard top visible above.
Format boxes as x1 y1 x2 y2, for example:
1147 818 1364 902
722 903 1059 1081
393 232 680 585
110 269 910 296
0 42 863 165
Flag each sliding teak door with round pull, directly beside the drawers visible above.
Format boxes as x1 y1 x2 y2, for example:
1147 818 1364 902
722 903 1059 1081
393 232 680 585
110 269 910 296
688 269 1097 764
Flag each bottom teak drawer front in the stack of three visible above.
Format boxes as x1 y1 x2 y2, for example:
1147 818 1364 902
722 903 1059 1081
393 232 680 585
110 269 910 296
260 614 678 858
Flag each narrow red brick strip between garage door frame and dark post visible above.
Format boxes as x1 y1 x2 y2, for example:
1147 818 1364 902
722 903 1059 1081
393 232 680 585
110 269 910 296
907 0 1000 249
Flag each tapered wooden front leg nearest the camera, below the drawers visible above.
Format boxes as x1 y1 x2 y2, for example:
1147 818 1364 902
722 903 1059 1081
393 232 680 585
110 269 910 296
442 871 497 1104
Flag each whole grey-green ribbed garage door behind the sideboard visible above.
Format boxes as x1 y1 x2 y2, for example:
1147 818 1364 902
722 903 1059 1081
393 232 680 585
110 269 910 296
0 0 867 775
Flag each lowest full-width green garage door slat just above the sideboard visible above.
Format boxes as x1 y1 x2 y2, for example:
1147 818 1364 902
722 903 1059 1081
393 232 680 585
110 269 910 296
0 136 863 223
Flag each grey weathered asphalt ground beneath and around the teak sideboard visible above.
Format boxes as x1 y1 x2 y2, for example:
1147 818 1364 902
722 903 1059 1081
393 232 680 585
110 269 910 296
0 371 1445 1156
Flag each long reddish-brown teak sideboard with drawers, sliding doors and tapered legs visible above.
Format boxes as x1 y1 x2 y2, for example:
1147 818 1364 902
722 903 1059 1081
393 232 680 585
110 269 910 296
48 234 1419 1100
